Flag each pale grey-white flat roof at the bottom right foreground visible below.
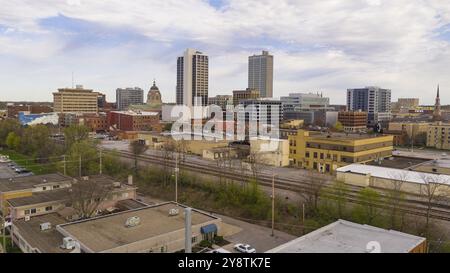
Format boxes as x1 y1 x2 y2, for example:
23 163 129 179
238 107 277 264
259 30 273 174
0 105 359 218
267 220 425 253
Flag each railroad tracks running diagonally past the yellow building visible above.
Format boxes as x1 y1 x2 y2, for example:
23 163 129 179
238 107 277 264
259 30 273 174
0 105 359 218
106 151 450 221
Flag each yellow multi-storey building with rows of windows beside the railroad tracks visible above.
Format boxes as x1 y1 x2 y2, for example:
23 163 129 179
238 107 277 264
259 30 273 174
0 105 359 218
289 130 393 173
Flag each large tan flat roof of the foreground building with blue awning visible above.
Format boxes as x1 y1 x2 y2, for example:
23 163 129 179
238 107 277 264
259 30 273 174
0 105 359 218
59 203 218 252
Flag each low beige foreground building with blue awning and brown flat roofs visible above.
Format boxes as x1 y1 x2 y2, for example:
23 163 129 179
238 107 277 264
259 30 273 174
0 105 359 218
12 202 225 253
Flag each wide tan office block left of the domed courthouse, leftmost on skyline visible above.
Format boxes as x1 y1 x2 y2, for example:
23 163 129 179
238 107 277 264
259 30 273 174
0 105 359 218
53 85 100 113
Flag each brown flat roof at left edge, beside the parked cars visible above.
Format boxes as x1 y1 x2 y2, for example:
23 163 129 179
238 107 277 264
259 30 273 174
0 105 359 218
0 173 73 192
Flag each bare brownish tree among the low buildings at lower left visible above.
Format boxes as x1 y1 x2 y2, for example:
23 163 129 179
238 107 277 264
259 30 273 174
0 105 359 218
68 179 113 219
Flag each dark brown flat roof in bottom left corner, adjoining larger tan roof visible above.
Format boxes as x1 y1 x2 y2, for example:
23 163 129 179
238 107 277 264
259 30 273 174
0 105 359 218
13 213 70 253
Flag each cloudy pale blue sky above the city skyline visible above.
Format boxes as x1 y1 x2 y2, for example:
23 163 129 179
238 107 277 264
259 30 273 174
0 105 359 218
0 0 450 104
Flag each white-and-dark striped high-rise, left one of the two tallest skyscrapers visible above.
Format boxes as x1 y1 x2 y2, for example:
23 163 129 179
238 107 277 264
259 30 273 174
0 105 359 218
176 48 209 106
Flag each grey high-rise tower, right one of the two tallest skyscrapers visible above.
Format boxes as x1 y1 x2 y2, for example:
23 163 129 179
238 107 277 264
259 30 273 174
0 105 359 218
248 51 273 98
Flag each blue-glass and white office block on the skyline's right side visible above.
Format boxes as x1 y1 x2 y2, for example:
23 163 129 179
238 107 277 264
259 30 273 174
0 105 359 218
347 86 391 125
